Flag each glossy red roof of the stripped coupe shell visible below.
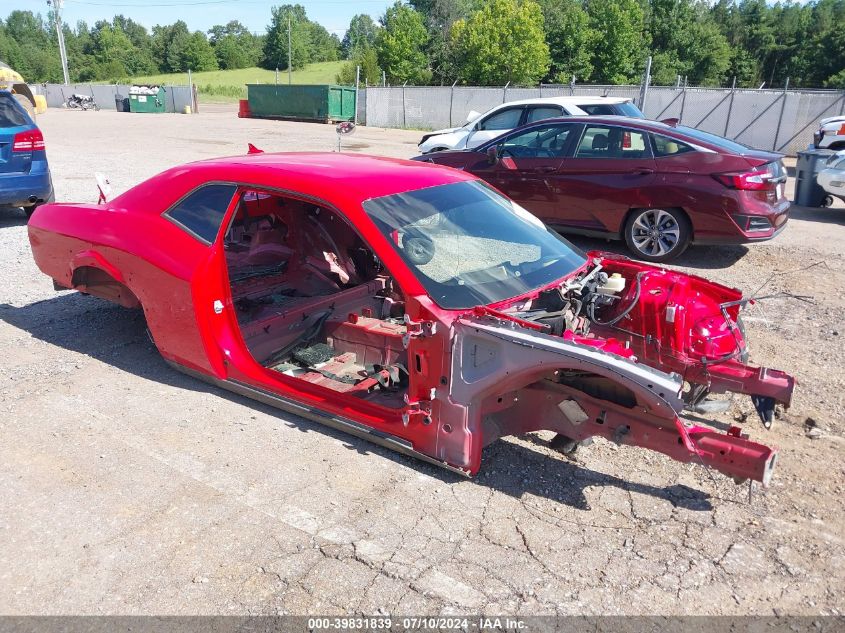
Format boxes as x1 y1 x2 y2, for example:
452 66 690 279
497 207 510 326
112 152 477 213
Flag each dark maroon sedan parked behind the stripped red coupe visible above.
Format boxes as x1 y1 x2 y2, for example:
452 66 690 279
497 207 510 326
416 117 789 262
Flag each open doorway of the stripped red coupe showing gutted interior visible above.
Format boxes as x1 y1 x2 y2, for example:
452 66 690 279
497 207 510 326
223 191 409 408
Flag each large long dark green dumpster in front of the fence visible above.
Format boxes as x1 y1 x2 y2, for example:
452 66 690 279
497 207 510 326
247 84 355 123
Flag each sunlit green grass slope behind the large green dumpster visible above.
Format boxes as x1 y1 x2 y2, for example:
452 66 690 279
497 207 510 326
132 61 346 101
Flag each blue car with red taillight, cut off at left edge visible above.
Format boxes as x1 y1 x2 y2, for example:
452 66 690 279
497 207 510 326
0 90 54 215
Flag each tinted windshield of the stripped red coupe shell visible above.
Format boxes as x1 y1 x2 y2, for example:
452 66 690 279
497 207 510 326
363 181 586 310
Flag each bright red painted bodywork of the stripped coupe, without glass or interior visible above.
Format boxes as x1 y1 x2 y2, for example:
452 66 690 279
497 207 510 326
29 153 792 479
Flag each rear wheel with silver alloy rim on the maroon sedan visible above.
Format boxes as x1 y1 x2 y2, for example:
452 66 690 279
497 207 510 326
624 208 692 262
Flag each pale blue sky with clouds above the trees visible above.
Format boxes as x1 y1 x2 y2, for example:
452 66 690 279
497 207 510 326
12 0 393 37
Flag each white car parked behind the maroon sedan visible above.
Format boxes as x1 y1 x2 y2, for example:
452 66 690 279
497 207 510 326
419 97 644 154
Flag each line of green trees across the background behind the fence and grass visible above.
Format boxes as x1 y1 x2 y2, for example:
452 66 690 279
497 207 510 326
0 0 845 88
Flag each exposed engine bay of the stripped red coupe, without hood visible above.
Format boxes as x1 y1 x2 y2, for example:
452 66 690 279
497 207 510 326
492 254 794 428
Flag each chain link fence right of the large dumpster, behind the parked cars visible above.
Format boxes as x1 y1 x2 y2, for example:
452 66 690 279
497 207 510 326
358 84 845 155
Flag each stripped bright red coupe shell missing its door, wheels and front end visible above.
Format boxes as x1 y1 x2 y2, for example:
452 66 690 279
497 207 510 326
29 153 794 483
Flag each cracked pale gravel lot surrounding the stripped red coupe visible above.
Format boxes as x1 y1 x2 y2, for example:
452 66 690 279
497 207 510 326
0 106 845 615
